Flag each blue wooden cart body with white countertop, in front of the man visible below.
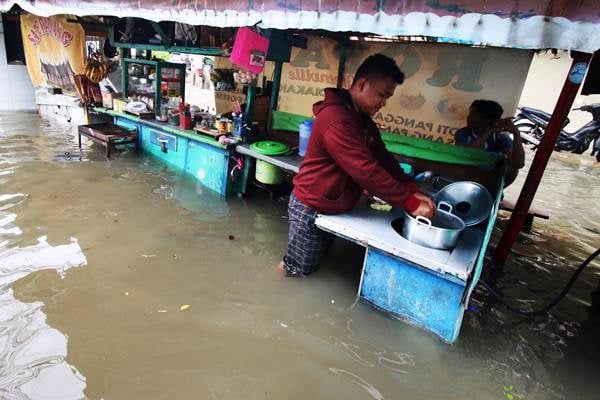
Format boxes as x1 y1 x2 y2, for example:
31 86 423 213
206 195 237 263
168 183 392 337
316 192 499 343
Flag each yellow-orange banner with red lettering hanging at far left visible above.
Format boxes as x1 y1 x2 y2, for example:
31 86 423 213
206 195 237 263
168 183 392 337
21 14 85 95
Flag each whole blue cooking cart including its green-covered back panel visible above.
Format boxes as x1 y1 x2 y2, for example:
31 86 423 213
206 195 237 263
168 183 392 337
315 135 505 343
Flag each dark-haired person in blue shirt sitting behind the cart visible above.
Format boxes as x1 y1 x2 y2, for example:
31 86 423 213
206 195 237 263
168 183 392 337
454 100 525 187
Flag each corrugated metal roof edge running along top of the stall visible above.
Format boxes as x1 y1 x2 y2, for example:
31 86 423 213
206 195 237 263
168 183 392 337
0 0 600 53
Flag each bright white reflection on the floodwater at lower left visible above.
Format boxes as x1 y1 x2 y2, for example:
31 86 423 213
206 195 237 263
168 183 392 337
0 232 86 400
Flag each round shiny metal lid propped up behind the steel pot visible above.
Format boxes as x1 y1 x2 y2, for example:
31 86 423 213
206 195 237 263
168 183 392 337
435 181 492 226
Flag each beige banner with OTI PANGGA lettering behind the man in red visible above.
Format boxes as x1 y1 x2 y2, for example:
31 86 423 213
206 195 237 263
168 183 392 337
279 37 532 143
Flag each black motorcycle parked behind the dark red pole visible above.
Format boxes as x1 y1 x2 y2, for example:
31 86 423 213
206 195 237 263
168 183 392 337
514 103 600 161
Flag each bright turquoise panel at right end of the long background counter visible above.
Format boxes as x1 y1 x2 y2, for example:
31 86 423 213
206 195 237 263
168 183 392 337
186 140 229 196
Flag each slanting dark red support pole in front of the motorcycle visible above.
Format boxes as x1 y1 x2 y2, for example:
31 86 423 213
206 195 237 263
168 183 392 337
493 52 592 265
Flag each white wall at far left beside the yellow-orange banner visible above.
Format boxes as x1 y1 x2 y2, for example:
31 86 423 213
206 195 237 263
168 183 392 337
0 17 37 111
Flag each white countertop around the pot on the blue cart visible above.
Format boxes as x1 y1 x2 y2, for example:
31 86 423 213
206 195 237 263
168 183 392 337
315 199 484 280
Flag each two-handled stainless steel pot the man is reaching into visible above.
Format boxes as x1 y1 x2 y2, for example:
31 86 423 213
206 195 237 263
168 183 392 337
402 201 465 250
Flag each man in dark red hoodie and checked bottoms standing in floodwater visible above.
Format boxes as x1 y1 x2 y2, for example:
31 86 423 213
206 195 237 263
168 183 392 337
281 54 435 276
